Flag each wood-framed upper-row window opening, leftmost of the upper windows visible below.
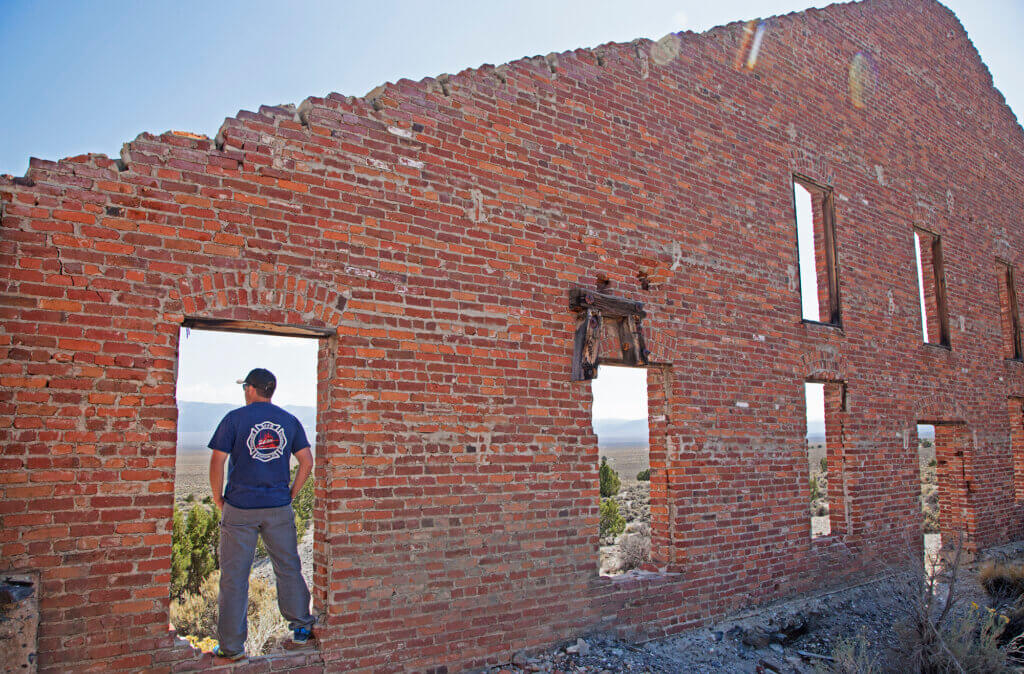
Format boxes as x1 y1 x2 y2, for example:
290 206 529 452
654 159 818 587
793 176 841 326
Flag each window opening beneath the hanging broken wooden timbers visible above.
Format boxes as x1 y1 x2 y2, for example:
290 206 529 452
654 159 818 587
591 365 651 576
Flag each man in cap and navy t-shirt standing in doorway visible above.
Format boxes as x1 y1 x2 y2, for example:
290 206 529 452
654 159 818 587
209 368 315 660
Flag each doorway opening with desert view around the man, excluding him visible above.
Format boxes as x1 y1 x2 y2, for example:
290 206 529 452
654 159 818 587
170 324 323 657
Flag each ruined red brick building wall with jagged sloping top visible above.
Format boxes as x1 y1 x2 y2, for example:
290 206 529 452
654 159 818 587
0 0 1024 672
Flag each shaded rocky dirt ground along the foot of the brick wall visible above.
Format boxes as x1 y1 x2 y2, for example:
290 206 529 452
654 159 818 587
489 539 1024 674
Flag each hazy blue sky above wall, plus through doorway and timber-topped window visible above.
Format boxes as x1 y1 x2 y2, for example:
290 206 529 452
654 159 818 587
0 0 1024 418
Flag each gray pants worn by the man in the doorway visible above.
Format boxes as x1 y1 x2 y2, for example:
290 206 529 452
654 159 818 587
217 503 315 652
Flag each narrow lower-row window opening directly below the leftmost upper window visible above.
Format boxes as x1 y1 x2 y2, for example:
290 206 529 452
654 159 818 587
804 381 847 539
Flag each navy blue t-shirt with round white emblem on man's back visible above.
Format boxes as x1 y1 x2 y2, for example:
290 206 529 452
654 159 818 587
208 403 309 508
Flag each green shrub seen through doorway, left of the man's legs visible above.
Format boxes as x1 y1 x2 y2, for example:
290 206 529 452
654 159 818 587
171 505 220 598
